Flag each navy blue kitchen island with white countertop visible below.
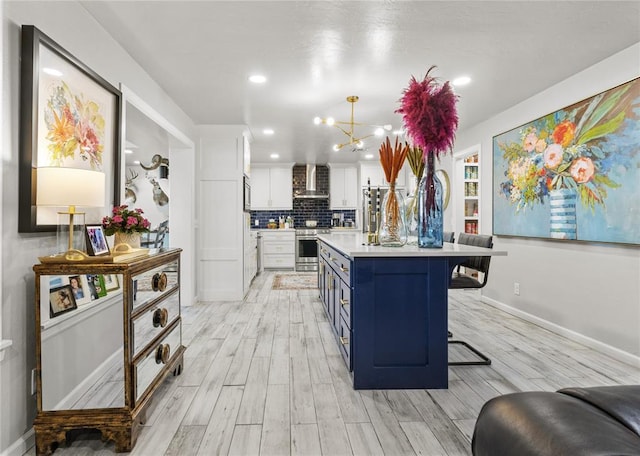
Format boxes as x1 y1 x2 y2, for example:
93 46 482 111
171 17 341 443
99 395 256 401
318 233 507 389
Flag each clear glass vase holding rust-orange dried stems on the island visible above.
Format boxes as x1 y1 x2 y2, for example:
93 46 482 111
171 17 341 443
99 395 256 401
378 136 409 247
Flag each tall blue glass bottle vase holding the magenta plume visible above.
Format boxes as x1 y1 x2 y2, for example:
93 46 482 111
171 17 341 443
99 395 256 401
418 153 443 248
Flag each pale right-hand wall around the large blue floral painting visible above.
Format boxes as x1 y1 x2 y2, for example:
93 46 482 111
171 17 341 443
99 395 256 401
456 43 640 365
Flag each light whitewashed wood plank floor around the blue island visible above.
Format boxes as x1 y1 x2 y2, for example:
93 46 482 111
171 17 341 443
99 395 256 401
27 273 640 456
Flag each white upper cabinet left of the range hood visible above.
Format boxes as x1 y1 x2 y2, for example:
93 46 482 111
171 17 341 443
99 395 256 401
251 164 293 210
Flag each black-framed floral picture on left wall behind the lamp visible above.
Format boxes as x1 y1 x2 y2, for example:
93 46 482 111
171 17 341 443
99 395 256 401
18 25 122 233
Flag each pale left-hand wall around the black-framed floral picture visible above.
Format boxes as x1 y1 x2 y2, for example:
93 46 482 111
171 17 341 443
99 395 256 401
0 1 195 455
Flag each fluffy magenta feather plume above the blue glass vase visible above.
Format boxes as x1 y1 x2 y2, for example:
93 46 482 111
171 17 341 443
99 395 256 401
396 66 458 157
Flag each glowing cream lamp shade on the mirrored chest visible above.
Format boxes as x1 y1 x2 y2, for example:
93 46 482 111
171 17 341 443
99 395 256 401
36 167 105 207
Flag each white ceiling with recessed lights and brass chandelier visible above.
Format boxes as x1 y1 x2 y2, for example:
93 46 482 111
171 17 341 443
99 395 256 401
80 0 640 163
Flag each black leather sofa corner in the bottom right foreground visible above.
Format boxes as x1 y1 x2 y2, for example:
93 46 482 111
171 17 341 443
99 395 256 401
471 385 640 456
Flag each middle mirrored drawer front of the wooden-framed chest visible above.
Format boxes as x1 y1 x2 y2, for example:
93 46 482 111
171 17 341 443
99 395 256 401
133 290 180 356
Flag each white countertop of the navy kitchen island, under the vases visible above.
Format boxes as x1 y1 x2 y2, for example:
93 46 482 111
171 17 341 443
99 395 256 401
318 232 507 258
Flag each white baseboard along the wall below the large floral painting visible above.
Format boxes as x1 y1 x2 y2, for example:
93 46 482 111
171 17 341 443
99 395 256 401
481 296 640 367
